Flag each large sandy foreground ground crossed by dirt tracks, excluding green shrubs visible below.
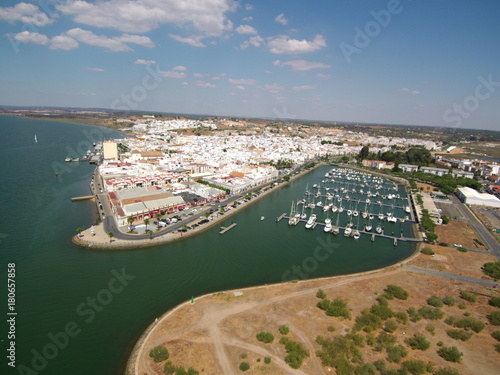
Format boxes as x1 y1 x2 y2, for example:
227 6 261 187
132 246 500 375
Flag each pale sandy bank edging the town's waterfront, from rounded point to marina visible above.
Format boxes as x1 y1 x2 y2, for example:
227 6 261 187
71 163 327 250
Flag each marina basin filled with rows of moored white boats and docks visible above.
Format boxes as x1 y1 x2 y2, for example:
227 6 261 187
276 167 422 246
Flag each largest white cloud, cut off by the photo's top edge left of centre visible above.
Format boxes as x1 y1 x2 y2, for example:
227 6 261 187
57 0 234 36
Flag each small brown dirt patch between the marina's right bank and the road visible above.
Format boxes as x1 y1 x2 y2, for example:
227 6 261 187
434 220 487 250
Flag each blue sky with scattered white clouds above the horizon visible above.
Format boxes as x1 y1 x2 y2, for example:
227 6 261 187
0 0 500 130
